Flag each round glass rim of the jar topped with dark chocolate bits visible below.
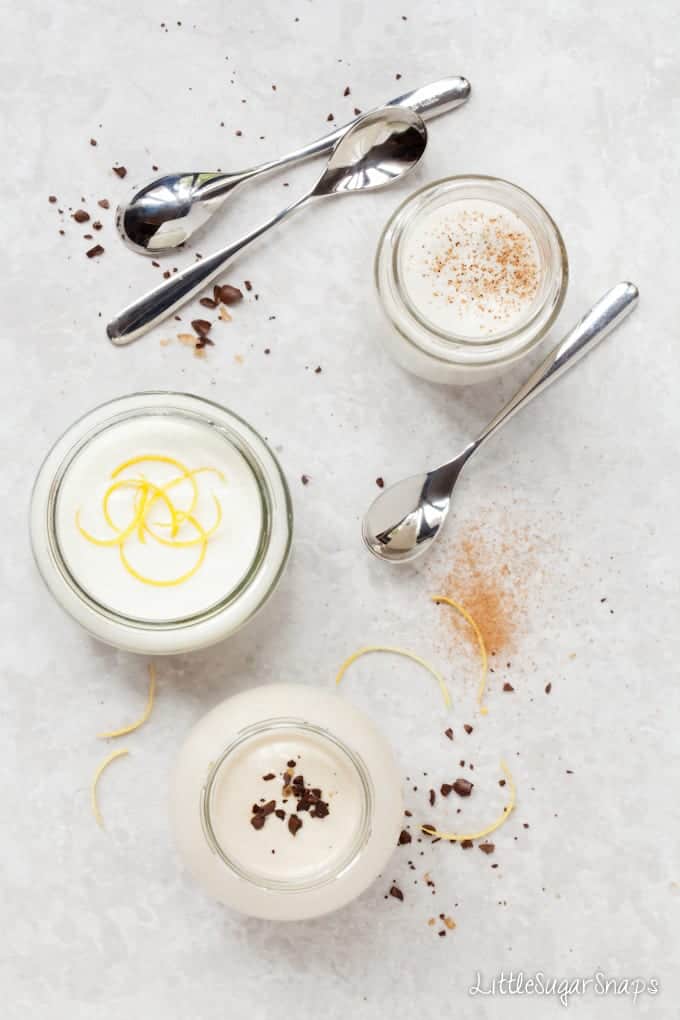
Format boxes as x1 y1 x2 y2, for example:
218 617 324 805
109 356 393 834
201 716 375 893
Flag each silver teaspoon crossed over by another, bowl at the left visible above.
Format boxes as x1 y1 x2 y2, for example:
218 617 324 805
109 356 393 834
116 78 470 255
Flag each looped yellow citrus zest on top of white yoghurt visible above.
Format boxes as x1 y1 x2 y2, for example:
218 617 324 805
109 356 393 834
75 454 225 588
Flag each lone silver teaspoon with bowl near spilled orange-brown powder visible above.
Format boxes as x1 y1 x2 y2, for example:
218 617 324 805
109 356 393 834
363 283 638 563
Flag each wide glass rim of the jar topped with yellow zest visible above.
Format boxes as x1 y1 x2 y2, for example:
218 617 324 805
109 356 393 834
31 391 293 652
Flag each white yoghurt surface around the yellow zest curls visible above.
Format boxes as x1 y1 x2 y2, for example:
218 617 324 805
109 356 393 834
55 415 263 621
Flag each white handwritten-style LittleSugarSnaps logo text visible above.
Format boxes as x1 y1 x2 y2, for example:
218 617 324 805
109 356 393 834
468 970 661 1007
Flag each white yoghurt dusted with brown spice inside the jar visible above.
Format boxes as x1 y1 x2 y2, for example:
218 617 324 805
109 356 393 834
400 198 541 341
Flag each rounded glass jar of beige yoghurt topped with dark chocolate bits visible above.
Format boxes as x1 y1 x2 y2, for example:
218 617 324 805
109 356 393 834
171 683 404 921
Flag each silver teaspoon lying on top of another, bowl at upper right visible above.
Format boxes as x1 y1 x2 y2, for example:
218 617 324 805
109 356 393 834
106 106 427 344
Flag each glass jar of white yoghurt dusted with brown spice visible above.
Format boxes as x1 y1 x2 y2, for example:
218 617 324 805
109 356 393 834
375 176 569 384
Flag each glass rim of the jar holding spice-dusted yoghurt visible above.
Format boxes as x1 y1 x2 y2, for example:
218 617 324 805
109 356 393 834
374 173 569 367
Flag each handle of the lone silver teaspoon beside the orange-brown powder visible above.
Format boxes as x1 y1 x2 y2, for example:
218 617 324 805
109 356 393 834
468 283 638 453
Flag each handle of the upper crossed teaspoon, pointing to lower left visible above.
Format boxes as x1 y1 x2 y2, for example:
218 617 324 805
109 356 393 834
106 194 311 346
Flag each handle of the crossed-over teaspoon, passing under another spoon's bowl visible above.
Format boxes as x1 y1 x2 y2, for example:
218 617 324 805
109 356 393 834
222 77 470 188
